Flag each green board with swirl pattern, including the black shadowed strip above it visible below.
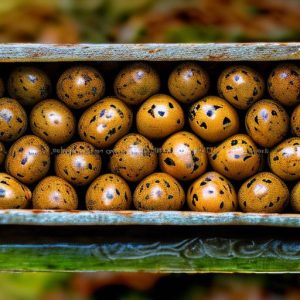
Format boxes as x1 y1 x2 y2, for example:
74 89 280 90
0 226 300 273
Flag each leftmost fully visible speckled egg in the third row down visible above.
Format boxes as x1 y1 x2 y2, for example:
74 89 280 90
5 135 50 184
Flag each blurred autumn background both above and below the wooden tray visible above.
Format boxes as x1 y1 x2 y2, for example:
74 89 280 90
0 0 300 300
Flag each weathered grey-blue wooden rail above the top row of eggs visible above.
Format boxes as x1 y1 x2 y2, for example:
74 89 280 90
0 43 300 62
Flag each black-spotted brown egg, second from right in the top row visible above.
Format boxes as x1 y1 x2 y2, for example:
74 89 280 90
218 65 265 109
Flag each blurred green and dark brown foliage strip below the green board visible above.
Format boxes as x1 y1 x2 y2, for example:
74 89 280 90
0 272 300 300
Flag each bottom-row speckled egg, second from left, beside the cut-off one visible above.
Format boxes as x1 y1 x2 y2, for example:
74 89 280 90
32 176 78 210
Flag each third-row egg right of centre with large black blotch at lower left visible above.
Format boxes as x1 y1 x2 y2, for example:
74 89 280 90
159 131 208 180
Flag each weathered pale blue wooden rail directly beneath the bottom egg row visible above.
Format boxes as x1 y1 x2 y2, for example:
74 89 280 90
0 209 300 228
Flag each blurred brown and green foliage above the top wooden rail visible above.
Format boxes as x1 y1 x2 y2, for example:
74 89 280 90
0 0 300 43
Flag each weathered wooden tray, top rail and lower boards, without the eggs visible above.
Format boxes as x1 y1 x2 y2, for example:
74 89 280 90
0 43 300 273
